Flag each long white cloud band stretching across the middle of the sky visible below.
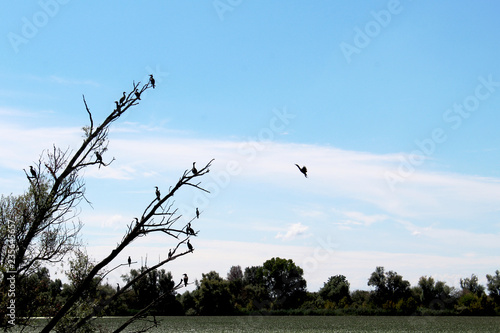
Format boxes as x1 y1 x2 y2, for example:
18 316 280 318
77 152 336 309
0 124 500 225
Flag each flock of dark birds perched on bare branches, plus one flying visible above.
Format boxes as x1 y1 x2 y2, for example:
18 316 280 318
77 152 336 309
26 74 307 291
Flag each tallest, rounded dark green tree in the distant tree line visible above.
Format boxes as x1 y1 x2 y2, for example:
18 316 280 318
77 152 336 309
262 258 306 309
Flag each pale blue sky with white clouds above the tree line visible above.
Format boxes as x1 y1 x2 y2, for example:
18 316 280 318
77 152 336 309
0 0 500 291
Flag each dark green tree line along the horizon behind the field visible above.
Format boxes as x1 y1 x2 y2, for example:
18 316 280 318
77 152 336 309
6 257 500 317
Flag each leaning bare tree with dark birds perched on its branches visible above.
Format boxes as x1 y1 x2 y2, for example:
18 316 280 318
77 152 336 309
0 76 213 332
